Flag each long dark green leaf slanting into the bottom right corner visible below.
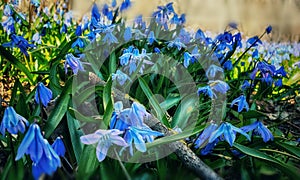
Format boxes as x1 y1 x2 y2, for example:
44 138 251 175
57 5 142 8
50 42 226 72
233 143 299 179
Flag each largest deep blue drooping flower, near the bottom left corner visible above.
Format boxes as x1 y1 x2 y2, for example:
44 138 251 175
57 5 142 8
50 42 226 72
15 123 61 179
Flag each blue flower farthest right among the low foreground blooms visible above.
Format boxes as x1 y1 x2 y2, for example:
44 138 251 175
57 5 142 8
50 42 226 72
241 121 274 142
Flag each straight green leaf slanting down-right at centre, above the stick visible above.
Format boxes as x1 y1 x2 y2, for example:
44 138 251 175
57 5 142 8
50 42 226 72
138 77 170 127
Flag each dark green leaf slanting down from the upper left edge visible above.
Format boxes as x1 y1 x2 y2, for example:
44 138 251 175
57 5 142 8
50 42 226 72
0 46 34 84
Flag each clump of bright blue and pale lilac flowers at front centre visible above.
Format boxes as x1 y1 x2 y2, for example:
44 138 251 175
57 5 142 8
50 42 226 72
80 101 163 162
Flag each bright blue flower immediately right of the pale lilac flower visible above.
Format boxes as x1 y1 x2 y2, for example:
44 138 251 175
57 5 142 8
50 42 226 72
124 126 164 155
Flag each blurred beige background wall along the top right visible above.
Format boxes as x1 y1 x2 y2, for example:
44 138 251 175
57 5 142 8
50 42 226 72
17 0 300 42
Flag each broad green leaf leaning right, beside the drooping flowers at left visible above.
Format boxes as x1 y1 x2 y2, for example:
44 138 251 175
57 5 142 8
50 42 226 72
45 78 72 138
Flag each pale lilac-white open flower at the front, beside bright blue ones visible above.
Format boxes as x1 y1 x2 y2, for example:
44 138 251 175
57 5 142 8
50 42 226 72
80 129 128 162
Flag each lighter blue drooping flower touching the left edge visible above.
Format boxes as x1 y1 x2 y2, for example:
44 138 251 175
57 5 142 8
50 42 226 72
0 106 29 136
